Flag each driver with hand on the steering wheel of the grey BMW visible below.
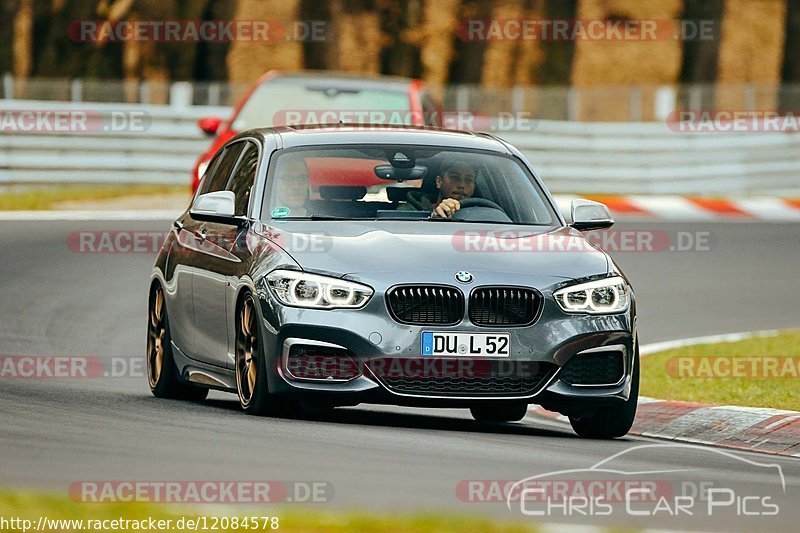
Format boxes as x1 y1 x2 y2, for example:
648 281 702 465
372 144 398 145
397 160 477 218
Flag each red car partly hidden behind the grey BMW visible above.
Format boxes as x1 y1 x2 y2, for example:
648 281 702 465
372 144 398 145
192 70 442 192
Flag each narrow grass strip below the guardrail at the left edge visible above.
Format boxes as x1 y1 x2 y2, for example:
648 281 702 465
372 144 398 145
0 185 189 211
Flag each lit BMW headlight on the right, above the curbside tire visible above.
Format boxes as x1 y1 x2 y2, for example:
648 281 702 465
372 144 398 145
553 276 630 315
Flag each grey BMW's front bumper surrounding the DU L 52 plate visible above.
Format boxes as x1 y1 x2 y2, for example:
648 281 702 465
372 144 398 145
259 280 635 414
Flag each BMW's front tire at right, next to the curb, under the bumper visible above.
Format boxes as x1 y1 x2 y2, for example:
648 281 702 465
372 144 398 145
569 344 639 439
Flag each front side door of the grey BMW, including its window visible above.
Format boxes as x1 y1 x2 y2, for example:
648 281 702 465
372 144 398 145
192 141 259 367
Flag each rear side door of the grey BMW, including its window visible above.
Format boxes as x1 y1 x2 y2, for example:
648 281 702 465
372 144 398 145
175 139 244 366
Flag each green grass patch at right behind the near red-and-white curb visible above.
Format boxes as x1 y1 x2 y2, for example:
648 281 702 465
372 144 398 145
641 330 800 411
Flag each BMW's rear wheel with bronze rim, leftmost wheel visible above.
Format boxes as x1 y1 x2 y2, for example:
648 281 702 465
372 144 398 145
145 285 208 402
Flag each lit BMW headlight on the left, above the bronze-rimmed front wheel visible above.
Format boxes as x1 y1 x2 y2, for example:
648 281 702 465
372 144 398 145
267 270 374 309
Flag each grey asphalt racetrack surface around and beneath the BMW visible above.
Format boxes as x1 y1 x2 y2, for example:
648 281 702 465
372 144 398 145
0 221 800 531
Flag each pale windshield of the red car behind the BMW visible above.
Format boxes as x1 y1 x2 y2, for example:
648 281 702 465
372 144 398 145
232 82 411 131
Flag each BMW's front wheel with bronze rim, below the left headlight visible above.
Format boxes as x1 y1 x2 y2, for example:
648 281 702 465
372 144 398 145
235 293 282 416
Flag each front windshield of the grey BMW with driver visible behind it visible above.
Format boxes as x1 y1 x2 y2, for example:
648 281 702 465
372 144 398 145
263 145 559 225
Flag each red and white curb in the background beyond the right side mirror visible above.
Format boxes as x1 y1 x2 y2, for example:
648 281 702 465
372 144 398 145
554 194 800 222
